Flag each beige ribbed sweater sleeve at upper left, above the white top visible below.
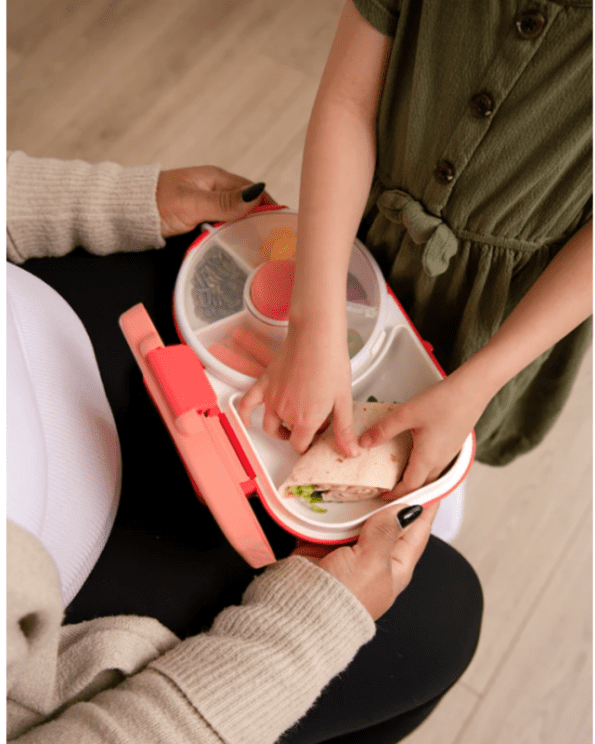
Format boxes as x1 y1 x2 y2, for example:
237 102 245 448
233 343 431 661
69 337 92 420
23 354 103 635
6 151 165 263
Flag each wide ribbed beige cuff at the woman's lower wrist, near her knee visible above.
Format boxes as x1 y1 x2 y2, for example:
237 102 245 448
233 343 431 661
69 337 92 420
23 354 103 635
151 556 375 744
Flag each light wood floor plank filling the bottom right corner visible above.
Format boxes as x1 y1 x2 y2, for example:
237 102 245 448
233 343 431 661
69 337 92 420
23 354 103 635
457 512 593 744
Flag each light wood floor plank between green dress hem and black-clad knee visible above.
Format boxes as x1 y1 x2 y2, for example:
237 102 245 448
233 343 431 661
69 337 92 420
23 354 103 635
454 354 592 693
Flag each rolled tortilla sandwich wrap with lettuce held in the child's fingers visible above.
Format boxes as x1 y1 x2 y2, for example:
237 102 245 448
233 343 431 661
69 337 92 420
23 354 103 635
279 402 413 502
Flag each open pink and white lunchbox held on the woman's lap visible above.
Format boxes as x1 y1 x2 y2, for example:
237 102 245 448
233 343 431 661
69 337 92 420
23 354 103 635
120 207 475 567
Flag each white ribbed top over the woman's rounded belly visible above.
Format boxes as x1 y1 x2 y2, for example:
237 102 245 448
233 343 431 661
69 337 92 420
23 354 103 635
6 259 121 606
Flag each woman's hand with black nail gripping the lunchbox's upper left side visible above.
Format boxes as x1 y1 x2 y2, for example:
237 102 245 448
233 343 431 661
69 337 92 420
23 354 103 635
157 165 276 238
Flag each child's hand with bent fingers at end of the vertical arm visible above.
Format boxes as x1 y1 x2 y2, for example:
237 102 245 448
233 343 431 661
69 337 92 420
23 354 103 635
239 325 359 457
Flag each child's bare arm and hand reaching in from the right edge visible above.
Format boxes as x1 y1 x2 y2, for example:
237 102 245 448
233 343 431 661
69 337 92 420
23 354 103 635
360 223 593 499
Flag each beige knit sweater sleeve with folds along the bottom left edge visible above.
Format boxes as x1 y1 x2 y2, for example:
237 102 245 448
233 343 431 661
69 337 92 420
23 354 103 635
8 524 375 744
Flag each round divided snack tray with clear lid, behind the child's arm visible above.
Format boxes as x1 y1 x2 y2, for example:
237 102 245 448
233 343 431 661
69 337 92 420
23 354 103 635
174 207 388 390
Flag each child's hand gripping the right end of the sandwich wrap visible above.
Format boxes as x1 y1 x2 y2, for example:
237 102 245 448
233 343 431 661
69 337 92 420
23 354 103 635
359 373 489 501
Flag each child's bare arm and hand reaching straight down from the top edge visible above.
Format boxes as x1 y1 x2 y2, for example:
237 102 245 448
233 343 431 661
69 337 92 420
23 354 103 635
240 0 390 455
